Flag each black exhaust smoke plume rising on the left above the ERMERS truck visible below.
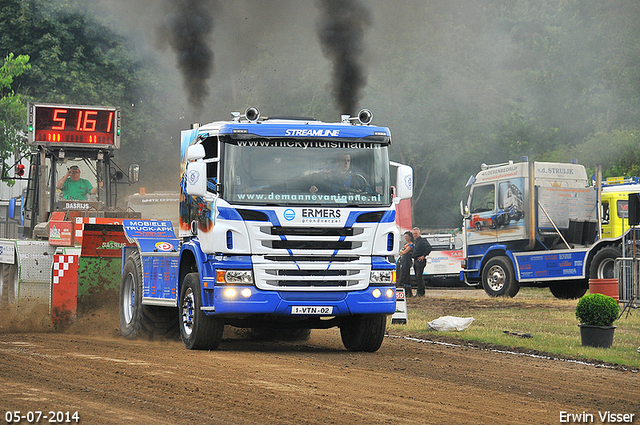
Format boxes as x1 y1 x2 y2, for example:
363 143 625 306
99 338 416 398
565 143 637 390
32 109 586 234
159 0 216 110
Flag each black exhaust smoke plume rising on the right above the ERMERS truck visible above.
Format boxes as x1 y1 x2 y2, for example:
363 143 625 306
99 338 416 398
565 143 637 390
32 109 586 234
317 0 371 115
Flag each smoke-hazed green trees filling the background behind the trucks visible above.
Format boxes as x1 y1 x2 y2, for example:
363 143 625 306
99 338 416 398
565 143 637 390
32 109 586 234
0 0 640 228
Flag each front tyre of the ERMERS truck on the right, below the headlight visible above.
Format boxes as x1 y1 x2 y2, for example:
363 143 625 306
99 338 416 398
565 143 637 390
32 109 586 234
340 315 387 353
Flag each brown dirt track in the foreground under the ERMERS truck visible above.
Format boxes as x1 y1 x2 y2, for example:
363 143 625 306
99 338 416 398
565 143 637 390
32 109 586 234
0 294 640 425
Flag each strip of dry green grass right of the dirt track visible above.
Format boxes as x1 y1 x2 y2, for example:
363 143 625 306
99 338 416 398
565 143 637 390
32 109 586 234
389 288 640 369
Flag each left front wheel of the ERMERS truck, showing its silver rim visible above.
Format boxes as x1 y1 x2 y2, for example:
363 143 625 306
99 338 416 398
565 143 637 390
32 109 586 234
180 273 224 350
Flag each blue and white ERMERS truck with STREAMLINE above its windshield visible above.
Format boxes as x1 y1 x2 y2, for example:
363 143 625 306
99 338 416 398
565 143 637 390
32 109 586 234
120 108 413 352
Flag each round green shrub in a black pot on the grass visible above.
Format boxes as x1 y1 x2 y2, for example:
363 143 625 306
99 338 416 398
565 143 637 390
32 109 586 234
576 294 620 348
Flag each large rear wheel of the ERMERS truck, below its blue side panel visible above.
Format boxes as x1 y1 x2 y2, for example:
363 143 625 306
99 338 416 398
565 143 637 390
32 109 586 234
118 251 178 339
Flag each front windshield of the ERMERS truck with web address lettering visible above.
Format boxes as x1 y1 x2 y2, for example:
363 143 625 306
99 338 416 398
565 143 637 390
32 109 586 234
222 139 391 206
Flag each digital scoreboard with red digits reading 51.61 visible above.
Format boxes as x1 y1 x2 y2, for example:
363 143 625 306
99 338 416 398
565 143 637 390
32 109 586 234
27 103 120 149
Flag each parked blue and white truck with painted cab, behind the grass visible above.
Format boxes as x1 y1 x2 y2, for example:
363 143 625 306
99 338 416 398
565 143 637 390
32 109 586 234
460 161 630 298
